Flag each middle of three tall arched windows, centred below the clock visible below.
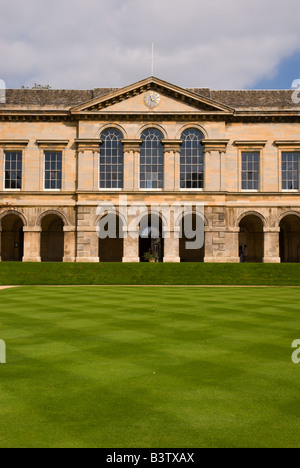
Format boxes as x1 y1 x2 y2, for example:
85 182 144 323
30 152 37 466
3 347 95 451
140 128 164 189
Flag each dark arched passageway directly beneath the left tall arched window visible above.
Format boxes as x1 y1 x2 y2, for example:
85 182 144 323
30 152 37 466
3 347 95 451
98 214 124 262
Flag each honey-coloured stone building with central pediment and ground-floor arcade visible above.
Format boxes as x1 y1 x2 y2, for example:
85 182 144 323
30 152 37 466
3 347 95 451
0 77 300 263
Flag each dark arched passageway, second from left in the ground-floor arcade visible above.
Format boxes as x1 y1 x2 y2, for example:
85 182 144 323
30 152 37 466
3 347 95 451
41 214 64 262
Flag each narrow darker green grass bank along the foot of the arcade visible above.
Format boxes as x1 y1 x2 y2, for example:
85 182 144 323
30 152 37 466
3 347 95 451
0 262 300 286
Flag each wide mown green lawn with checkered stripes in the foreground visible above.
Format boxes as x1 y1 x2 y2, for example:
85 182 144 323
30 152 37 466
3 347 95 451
0 287 300 448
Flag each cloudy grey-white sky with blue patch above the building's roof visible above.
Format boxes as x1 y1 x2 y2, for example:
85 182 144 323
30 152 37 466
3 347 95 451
0 0 300 89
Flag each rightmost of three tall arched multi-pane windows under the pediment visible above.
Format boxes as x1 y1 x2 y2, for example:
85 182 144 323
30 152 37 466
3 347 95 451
180 129 204 189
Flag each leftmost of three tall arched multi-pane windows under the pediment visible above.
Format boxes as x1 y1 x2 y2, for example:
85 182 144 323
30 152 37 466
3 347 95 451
99 128 124 189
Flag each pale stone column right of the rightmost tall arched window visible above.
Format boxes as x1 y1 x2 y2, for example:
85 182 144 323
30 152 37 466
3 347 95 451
202 139 229 192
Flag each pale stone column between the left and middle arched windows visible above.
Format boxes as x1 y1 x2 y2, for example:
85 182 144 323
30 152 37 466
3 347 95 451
122 140 143 192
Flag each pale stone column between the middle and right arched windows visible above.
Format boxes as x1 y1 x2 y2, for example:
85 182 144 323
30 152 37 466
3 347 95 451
162 140 183 192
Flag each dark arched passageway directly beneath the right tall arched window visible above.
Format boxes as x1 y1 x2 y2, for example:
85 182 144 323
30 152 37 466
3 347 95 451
179 214 205 263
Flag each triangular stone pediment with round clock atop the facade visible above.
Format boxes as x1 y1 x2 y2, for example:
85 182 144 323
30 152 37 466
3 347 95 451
70 77 234 115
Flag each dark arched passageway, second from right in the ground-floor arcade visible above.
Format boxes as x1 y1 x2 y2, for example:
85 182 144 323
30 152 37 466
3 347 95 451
239 215 264 263
